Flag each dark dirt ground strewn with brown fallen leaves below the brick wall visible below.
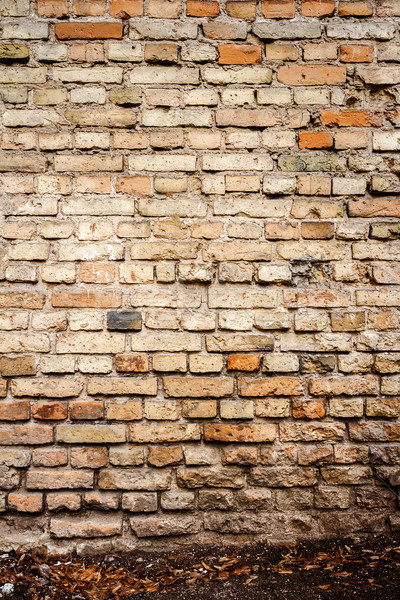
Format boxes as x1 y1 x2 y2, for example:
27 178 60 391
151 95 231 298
0 535 400 600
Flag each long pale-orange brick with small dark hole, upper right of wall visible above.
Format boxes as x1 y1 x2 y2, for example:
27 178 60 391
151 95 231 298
277 65 346 85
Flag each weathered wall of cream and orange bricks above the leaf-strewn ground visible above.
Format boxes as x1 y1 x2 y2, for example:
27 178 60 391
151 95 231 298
0 0 400 550
